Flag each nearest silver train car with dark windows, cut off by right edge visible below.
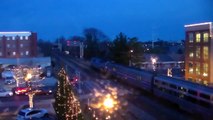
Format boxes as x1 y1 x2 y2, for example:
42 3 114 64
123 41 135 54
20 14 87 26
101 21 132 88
153 76 213 119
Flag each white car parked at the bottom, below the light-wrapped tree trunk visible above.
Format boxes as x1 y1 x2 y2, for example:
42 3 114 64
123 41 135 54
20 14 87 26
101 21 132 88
16 108 48 120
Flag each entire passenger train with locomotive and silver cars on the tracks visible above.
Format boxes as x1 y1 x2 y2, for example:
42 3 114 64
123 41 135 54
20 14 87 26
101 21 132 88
91 58 213 119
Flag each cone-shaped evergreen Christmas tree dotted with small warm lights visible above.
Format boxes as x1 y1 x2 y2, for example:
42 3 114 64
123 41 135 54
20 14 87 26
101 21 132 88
54 68 82 120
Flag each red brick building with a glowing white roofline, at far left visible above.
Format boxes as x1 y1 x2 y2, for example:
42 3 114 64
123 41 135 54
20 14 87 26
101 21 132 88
0 32 37 58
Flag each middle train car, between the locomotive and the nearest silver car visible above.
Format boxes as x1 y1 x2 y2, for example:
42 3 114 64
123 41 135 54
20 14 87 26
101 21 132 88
105 63 154 92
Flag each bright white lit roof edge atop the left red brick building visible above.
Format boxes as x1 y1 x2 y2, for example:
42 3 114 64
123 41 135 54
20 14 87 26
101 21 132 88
0 31 31 37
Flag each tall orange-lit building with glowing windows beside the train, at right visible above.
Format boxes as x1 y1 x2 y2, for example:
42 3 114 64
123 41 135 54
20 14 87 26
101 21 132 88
185 22 213 85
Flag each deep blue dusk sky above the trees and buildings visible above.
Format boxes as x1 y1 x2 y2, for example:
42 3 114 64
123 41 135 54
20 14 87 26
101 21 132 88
0 0 213 41
